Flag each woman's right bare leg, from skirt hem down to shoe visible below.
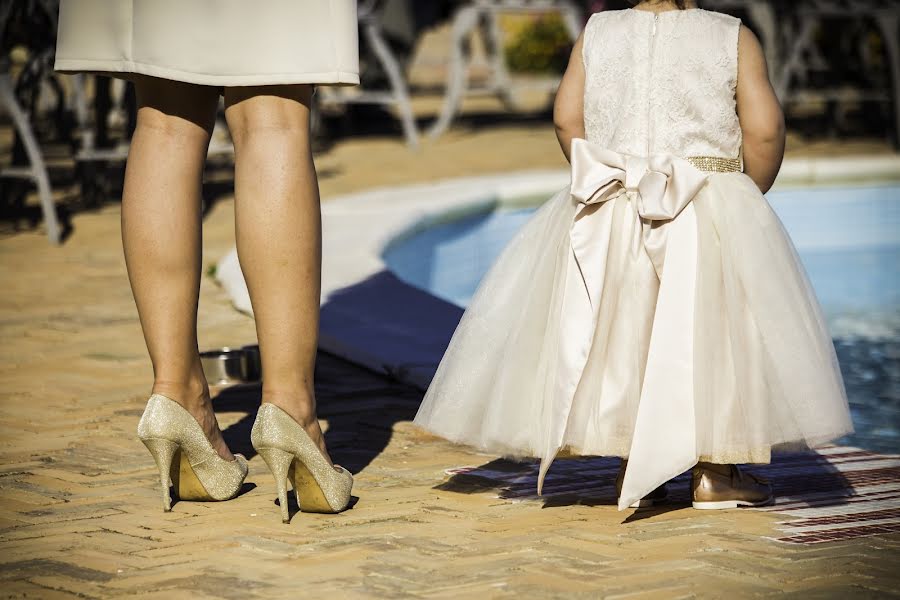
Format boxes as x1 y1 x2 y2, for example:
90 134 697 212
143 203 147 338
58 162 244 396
225 85 330 460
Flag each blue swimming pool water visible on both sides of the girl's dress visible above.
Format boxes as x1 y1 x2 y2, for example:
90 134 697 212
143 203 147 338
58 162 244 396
384 186 900 452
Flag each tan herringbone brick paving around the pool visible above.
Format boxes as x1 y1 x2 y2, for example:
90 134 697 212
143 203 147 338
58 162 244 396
0 116 900 599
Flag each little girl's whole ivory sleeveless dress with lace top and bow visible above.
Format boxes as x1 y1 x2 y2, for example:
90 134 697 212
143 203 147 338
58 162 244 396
415 9 852 509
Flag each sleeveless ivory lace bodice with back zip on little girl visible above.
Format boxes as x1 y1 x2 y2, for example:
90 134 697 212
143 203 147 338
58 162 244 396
583 9 741 158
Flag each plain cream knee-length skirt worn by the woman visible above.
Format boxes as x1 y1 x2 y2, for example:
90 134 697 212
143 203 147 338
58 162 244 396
56 0 359 86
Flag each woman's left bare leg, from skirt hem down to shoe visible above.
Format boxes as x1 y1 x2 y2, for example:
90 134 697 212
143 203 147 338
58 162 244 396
122 77 233 459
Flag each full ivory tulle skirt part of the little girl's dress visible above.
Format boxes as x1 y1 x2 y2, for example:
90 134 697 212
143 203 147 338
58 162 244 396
415 173 852 506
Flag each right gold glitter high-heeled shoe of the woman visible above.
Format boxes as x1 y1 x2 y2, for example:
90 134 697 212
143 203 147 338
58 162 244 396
250 402 353 523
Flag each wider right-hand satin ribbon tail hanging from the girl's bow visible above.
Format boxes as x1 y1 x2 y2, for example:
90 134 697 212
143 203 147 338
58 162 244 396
619 204 698 510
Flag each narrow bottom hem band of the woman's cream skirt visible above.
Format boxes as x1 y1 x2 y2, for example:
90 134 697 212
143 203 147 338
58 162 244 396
54 58 359 87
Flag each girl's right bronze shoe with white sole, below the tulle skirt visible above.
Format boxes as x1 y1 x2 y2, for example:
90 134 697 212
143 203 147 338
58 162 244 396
691 463 774 510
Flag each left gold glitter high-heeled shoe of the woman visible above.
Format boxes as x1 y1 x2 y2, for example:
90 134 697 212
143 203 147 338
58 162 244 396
138 394 247 512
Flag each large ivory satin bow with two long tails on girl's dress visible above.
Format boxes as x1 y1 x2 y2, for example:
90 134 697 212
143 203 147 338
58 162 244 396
538 139 707 509
